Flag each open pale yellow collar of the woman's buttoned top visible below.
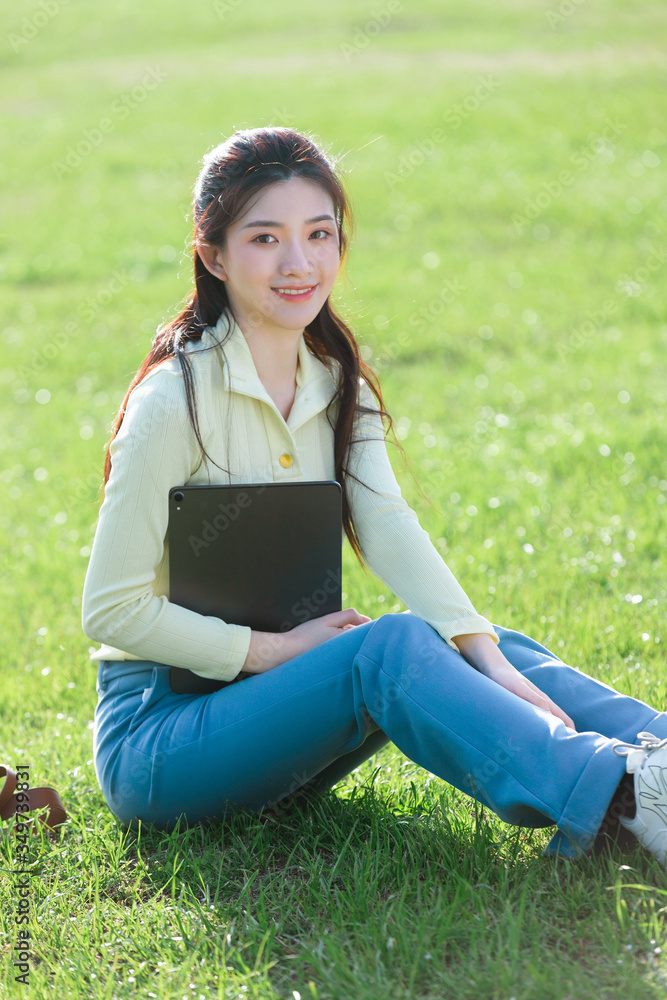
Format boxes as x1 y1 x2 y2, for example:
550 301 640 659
202 311 336 430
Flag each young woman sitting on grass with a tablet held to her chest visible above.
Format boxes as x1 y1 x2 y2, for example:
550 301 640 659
83 128 667 864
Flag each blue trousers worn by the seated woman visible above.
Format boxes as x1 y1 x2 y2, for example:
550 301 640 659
94 612 667 857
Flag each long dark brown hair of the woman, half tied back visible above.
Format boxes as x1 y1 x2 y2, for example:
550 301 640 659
104 126 420 566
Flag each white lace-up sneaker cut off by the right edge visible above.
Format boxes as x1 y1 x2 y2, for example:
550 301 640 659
613 733 667 868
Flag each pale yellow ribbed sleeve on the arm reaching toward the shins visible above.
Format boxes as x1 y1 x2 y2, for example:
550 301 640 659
348 380 499 651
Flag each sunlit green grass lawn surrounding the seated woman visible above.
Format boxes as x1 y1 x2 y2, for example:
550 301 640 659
0 0 667 1000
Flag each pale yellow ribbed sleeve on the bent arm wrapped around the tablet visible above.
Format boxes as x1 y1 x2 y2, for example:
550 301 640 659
82 366 251 681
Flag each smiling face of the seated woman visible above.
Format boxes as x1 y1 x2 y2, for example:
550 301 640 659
207 176 340 334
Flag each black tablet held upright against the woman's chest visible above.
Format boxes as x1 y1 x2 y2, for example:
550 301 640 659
167 481 342 693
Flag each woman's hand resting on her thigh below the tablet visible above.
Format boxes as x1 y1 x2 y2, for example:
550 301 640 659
243 608 371 674
